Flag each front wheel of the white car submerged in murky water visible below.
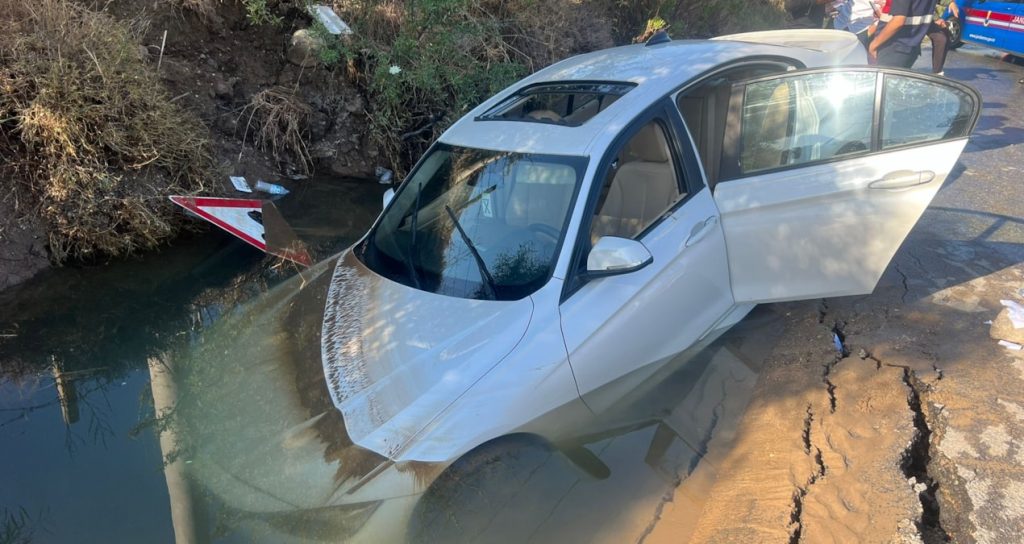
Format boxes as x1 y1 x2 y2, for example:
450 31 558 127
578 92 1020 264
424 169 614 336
408 434 571 543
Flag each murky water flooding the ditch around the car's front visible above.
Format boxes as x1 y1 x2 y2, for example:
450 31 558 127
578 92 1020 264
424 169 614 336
0 176 779 543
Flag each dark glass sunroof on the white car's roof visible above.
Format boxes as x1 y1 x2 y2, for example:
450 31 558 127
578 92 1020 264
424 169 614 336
476 81 636 127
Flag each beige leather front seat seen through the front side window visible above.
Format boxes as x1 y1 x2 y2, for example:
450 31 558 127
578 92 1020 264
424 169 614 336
591 123 682 243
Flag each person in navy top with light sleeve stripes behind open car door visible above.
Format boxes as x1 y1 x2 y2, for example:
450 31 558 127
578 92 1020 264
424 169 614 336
867 0 937 69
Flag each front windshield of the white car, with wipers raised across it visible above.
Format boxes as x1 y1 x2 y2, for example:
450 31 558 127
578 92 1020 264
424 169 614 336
358 144 587 300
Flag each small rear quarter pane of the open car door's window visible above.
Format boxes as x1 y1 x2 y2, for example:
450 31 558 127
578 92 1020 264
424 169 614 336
882 74 974 150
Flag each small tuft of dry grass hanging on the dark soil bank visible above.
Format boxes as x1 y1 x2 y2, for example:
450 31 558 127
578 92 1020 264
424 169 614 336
242 87 312 174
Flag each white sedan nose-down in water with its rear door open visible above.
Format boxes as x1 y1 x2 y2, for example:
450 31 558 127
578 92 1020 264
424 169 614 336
180 31 981 540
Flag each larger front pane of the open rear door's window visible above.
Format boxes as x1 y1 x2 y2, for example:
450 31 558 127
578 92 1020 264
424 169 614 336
739 72 878 174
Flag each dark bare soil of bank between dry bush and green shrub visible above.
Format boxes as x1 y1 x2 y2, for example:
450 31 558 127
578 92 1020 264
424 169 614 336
98 0 376 183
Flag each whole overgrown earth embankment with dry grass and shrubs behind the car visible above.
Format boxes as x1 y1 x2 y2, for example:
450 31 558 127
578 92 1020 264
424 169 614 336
0 0 800 289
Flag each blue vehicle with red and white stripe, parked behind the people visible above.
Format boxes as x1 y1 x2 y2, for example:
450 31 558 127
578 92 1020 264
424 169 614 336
947 0 1024 56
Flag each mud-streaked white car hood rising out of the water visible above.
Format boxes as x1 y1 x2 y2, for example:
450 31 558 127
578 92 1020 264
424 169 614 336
321 251 534 461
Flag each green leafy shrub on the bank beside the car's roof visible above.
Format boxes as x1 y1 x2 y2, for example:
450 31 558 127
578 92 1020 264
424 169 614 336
335 0 610 171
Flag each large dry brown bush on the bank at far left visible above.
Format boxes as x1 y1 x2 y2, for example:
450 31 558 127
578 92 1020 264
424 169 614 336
0 0 212 262
